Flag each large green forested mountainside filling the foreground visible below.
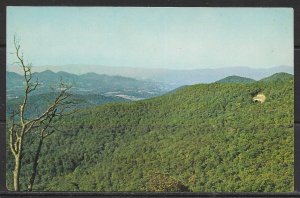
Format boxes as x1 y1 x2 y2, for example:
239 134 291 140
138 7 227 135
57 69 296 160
7 76 294 192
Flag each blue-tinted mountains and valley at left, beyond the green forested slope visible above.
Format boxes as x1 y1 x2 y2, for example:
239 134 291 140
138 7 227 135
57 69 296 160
6 70 169 100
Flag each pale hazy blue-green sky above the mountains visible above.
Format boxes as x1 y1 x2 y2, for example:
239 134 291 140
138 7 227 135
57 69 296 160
7 7 293 69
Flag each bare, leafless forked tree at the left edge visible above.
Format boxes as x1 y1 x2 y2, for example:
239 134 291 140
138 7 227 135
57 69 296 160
9 38 74 191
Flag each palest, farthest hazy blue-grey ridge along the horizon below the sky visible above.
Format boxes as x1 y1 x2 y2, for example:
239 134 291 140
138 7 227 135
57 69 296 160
7 64 294 89
